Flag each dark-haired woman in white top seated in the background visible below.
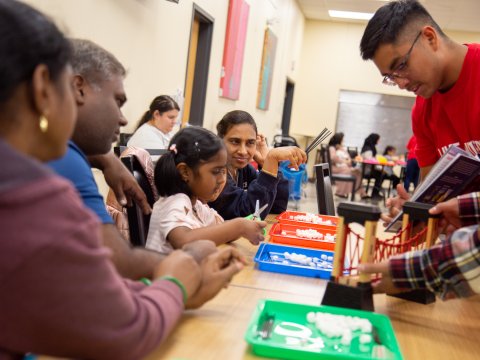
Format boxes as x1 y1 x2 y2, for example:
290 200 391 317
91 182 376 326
127 95 180 149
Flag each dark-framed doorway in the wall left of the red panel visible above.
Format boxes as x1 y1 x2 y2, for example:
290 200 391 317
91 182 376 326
182 4 213 127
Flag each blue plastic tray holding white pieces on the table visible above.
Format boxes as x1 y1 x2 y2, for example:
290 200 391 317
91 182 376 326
254 243 333 279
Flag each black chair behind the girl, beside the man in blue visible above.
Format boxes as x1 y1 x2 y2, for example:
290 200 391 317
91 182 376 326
120 156 155 246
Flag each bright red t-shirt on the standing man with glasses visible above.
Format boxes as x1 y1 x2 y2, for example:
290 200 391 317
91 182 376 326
412 44 480 167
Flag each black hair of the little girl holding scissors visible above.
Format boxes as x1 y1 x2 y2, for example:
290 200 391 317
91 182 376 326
154 126 225 197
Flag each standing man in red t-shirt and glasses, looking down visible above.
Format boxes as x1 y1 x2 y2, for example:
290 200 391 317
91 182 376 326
360 0 480 220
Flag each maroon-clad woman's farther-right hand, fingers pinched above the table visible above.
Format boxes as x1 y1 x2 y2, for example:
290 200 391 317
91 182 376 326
186 246 246 309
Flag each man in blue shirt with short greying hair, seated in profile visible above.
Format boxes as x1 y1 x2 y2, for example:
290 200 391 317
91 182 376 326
50 39 163 279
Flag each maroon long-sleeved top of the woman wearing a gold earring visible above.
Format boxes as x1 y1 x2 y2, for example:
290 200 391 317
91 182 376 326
0 177 183 359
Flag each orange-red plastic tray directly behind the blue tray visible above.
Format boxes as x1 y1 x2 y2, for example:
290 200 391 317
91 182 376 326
269 223 335 251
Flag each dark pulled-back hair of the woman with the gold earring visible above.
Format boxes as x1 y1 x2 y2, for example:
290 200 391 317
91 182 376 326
0 0 71 103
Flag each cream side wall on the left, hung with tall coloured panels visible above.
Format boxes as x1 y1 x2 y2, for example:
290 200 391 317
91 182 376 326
26 0 304 137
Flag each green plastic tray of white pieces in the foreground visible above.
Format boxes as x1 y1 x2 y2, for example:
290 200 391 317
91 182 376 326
245 300 403 360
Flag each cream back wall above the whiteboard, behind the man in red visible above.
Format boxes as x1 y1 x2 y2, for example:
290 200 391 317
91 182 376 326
290 21 480 136
